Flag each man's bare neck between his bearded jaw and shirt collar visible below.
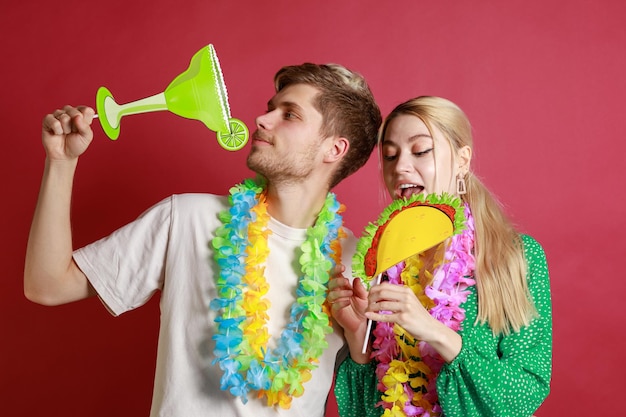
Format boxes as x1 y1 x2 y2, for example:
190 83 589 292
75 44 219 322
267 182 328 229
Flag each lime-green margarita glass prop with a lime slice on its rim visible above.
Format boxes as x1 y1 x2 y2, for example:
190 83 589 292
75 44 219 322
96 45 249 151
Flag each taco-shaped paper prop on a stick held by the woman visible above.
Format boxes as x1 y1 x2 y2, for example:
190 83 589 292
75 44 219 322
352 194 464 353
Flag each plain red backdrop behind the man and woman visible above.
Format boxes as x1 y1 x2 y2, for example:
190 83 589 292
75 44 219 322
0 0 626 417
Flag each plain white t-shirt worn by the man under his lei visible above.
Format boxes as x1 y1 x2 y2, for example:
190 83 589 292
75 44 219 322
74 194 356 417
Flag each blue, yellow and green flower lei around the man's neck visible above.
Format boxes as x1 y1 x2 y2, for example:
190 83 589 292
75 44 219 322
210 179 345 409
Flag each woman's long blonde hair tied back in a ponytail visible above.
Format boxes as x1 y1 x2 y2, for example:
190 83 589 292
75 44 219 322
379 96 537 334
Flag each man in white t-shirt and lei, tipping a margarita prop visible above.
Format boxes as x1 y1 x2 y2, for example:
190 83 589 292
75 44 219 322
24 64 381 417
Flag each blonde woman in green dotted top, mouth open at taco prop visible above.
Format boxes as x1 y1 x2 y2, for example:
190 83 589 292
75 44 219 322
328 97 552 417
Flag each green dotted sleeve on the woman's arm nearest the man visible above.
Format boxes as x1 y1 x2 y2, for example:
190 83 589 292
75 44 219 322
334 357 382 417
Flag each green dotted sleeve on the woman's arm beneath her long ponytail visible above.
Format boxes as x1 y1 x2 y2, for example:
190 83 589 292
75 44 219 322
437 236 552 417
